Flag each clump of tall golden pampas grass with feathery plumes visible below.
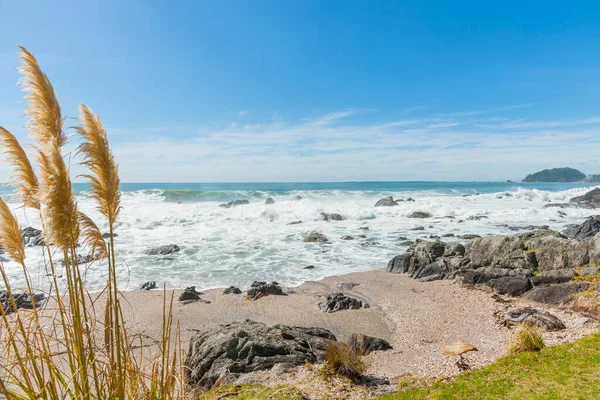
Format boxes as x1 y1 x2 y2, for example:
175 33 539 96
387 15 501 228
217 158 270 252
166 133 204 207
0 47 187 400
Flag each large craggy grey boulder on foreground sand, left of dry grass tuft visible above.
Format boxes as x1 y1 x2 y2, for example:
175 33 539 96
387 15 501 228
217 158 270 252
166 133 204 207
184 320 336 388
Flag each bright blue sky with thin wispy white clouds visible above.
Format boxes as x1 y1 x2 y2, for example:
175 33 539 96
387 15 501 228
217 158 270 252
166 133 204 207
0 0 600 182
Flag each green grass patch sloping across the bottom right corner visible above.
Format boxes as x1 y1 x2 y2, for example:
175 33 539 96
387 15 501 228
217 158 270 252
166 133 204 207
379 333 600 400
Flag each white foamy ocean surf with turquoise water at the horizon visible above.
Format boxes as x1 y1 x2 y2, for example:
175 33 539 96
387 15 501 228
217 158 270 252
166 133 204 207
0 182 591 291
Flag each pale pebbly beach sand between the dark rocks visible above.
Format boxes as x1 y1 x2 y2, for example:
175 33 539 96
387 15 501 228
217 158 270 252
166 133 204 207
116 269 598 379
